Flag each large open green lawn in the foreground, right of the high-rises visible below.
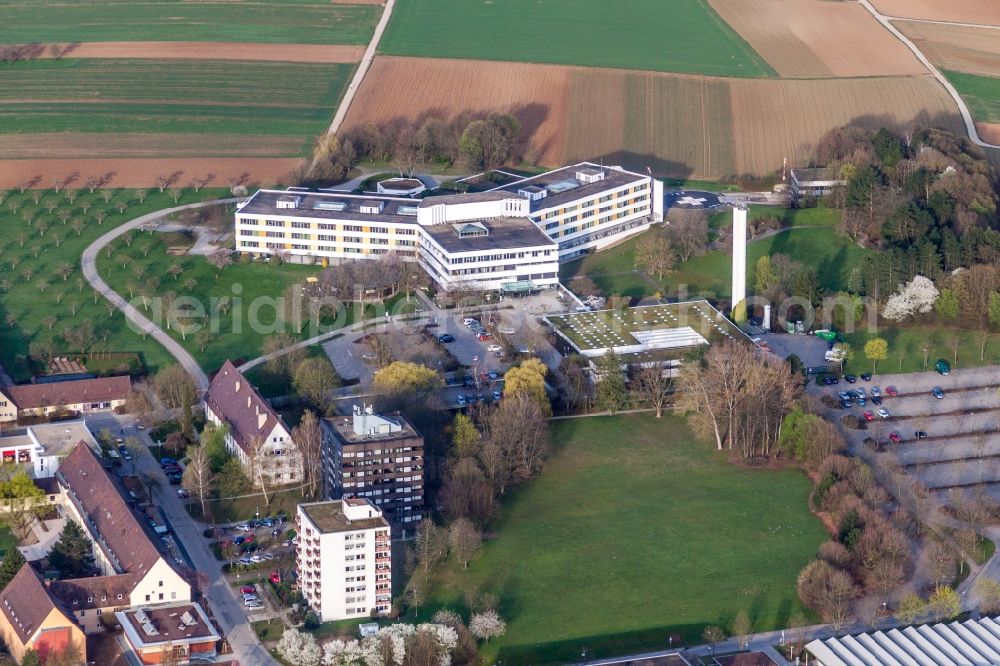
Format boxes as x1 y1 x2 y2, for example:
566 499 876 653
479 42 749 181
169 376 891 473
426 416 826 664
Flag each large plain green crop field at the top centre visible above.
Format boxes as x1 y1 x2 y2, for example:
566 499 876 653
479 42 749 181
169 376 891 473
380 0 774 77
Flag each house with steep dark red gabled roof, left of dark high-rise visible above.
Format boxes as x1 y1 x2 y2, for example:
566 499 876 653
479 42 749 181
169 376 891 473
205 360 302 486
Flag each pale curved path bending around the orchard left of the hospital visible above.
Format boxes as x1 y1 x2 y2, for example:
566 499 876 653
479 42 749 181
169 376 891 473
80 198 237 391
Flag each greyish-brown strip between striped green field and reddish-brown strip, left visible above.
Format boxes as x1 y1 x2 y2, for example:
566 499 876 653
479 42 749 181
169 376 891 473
0 132 304 159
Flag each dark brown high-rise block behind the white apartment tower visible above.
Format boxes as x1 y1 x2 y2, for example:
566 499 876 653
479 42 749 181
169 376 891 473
323 405 424 532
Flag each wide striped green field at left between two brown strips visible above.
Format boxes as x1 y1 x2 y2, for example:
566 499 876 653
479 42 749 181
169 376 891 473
0 59 354 140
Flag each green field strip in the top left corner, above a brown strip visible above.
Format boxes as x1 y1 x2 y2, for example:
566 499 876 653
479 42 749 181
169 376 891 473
0 0 382 44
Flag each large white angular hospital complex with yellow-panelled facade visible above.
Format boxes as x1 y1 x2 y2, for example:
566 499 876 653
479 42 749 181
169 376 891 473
236 162 663 290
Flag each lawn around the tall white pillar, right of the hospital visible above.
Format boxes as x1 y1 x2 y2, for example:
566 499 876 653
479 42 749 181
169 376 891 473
560 207 866 300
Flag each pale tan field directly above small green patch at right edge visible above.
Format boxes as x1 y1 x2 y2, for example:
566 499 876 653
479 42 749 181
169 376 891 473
896 21 1000 76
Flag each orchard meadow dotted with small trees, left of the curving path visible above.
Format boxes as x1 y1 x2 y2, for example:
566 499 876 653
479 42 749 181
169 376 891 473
0 183 228 381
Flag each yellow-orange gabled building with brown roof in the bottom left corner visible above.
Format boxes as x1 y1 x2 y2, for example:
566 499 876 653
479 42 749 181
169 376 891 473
0 563 87 663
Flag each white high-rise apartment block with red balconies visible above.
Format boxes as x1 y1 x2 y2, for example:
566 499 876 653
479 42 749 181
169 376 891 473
296 499 392 622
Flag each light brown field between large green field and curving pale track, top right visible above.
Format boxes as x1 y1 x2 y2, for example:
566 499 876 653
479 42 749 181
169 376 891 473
709 0 927 78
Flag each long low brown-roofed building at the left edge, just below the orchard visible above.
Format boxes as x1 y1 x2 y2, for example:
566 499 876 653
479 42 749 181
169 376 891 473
0 377 132 422
